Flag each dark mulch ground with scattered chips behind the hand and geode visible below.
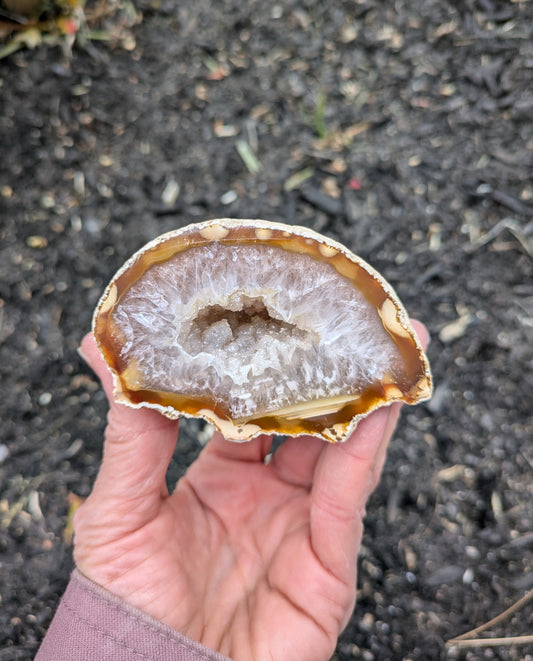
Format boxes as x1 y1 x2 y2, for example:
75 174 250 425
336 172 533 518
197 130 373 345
0 0 533 661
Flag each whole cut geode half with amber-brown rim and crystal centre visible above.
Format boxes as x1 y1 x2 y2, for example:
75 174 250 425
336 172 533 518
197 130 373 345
93 219 432 441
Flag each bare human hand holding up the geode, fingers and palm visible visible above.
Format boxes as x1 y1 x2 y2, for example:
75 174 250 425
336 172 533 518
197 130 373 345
74 322 427 661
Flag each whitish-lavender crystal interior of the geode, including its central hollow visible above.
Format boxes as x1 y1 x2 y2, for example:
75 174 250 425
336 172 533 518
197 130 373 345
113 242 402 419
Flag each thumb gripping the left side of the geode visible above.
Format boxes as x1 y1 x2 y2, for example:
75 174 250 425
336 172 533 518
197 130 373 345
79 333 178 506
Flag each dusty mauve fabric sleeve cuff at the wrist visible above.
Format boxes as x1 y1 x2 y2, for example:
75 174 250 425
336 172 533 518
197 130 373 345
35 570 230 661
